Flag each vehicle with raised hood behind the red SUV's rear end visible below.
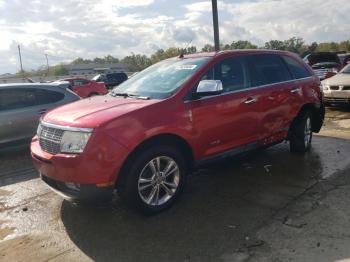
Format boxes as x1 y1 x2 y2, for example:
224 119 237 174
304 52 343 80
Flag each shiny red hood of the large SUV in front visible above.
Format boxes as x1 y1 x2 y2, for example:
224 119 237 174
43 95 160 128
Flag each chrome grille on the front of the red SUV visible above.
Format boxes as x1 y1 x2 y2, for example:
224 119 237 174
38 124 64 155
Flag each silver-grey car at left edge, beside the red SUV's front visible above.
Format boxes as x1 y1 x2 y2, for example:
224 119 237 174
0 82 80 150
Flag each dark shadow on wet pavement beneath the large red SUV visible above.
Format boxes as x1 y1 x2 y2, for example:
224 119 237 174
61 137 350 261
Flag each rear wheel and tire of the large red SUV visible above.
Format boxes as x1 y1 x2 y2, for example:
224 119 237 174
289 111 312 153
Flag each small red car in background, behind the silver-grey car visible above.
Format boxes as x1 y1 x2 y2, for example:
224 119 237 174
61 77 108 98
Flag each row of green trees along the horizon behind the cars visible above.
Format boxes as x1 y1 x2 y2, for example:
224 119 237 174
14 37 350 75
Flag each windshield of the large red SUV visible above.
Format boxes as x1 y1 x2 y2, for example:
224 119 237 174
112 57 210 99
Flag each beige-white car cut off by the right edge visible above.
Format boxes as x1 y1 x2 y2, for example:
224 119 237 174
322 64 350 105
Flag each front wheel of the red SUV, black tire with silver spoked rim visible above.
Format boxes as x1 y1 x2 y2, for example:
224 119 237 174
118 146 187 213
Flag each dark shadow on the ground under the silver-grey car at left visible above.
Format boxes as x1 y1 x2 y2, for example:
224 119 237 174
0 146 39 187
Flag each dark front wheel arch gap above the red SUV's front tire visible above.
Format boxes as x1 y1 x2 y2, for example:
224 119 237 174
116 133 194 187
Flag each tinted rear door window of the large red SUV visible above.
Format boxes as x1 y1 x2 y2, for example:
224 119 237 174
248 54 292 87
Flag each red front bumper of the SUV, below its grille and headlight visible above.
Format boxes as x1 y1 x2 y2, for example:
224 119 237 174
31 130 128 199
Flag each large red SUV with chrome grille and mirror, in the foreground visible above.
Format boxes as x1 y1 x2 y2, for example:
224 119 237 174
31 50 324 212
